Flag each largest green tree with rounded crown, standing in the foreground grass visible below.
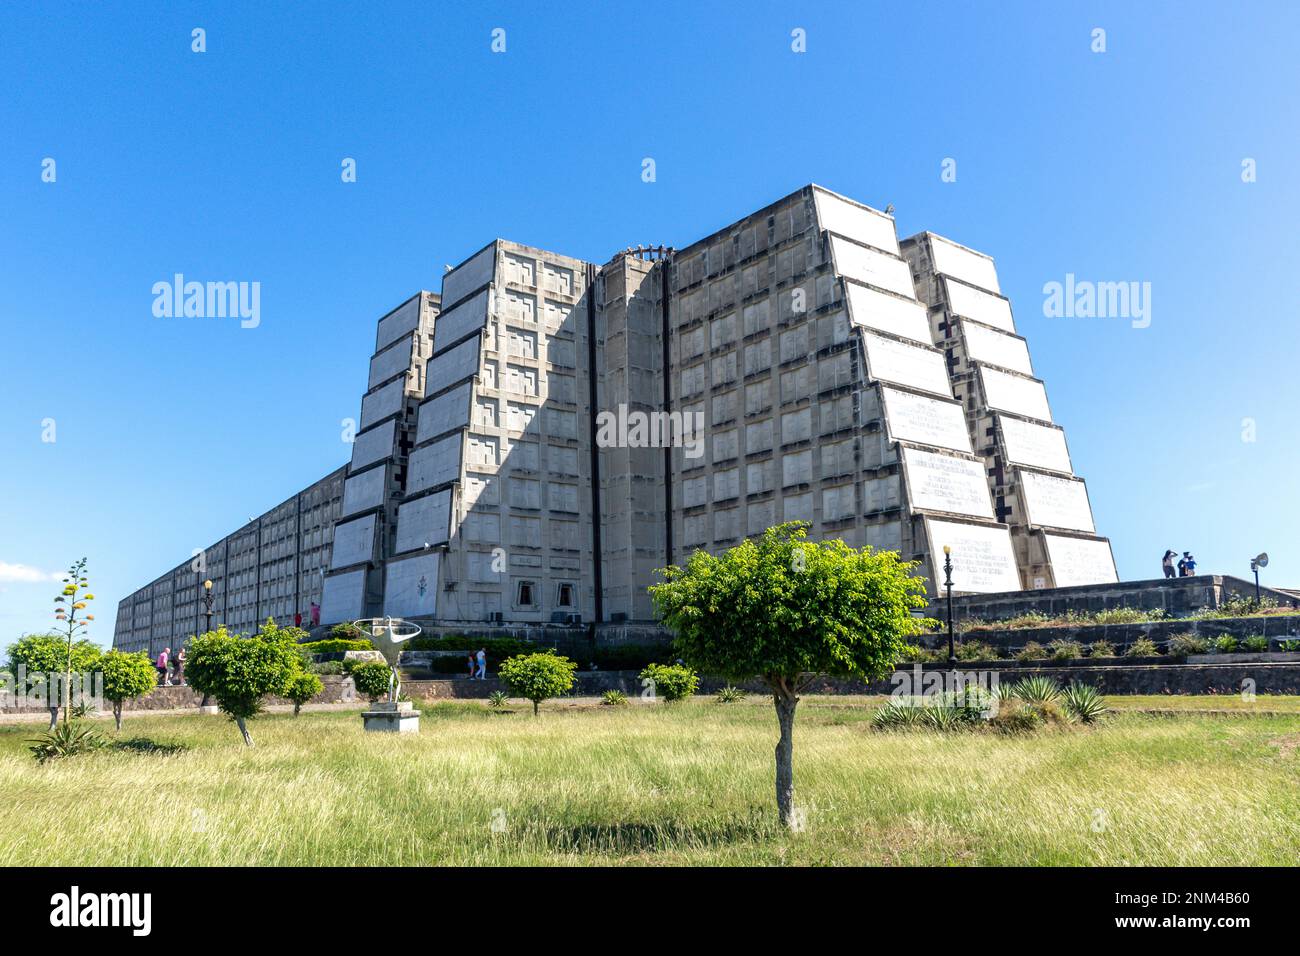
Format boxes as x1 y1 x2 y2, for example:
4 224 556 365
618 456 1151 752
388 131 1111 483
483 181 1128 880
650 522 926 826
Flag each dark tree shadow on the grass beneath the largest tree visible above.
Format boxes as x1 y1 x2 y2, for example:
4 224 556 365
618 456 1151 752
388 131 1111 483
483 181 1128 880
543 809 779 853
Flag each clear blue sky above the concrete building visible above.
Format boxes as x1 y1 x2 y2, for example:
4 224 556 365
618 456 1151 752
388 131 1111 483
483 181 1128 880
0 3 1300 644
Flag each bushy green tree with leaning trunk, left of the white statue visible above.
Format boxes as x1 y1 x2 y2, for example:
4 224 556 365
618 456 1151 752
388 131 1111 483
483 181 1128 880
185 627 302 747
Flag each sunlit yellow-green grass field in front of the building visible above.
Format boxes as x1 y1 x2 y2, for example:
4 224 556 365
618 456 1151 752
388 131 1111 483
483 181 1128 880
0 697 1300 866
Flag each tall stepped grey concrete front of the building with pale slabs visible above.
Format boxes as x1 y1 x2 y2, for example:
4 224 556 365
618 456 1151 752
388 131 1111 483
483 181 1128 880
117 186 1114 648
